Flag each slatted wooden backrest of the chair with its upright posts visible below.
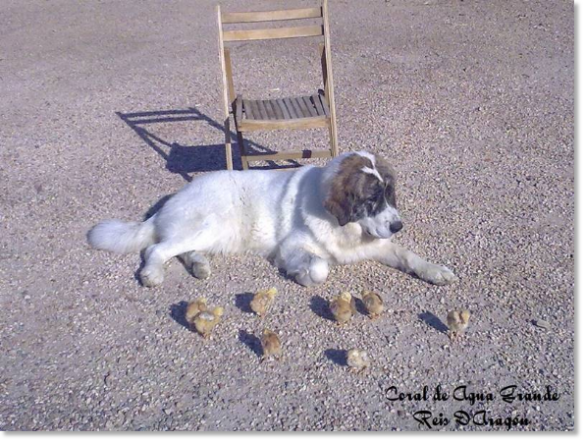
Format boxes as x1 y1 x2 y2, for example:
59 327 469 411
217 0 334 108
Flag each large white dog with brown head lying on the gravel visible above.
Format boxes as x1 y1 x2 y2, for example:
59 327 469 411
88 152 457 287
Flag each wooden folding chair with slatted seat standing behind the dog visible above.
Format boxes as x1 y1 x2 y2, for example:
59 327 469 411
217 0 338 169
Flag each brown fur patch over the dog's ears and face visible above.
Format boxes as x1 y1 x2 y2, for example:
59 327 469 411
323 154 396 226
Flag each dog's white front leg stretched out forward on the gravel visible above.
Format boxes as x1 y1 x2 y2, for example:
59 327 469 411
374 241 458 285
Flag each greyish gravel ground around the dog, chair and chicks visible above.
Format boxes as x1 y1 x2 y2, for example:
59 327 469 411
0 0 574 430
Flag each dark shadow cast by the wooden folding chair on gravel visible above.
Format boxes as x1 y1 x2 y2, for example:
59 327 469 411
116 107 300 182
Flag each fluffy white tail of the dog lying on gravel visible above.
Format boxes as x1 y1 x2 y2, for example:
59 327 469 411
87 215 156 253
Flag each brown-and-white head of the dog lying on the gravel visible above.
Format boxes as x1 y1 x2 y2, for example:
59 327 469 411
323 152 402 242
